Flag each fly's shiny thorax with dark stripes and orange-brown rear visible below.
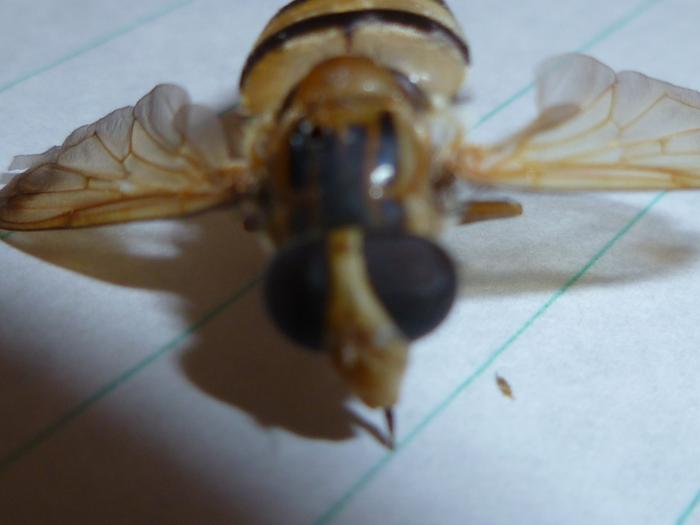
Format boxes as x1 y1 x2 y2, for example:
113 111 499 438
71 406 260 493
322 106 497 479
254 57 438 244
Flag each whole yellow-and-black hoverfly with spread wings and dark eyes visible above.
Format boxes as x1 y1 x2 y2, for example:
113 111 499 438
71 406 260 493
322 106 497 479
0 0 700 444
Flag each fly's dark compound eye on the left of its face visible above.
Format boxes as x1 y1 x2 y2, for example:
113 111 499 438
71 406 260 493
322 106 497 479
264 240 328 350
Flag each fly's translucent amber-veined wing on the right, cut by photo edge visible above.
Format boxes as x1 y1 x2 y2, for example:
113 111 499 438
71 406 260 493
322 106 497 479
450 54 700 190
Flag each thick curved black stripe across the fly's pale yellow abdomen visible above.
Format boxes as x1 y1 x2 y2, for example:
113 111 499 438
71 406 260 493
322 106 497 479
240 9 469 88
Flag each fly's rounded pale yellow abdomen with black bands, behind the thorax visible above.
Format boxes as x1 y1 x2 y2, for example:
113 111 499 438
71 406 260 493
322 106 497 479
241 0 469 114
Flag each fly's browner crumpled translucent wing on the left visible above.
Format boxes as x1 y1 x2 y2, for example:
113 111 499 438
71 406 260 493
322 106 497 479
0 84 246 230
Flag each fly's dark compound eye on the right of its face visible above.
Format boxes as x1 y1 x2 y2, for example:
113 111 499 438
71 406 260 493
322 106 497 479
365 234 457 339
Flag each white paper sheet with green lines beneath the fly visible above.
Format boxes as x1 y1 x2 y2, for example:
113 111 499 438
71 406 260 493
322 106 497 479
0 0 700 525
